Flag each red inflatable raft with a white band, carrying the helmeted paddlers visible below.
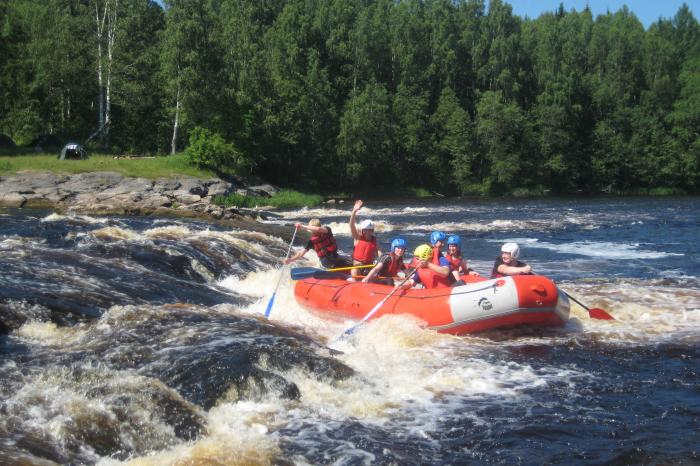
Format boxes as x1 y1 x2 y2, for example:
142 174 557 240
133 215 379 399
294 275 570 335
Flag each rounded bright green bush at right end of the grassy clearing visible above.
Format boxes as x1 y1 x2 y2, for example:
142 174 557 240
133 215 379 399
185 126 248 173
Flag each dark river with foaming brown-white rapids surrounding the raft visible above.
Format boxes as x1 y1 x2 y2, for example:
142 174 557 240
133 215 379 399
0 197 700 465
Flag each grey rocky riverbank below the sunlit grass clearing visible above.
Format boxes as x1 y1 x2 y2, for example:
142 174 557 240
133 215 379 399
0 171 290 233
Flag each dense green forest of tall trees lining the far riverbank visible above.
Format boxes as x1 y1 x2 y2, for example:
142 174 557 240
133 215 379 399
0 0 700 195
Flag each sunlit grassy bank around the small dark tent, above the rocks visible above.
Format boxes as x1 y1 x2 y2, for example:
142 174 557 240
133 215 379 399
0 153 216 179
